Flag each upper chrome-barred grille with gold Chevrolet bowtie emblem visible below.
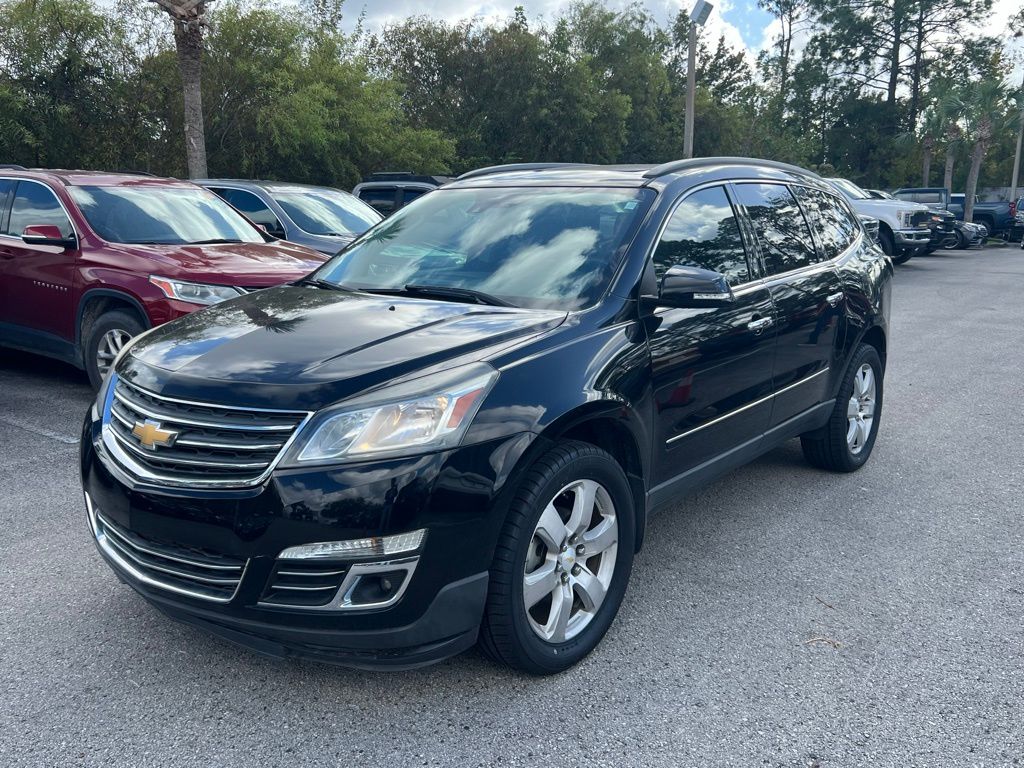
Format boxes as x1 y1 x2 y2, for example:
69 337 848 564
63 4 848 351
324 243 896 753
103 378 309 487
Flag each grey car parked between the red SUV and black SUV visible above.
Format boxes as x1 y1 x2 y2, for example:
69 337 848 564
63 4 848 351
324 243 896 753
196 178 381 256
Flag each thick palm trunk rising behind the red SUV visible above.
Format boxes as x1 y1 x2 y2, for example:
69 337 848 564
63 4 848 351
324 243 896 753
151 0 207 178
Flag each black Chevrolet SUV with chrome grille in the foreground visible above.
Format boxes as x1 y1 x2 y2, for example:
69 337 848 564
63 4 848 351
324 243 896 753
82 158 892 674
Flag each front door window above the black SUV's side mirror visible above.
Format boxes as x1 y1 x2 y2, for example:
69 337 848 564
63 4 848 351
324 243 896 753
654 186 751 286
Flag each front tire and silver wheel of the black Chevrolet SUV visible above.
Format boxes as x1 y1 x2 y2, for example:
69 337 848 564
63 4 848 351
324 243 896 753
480 440 636 675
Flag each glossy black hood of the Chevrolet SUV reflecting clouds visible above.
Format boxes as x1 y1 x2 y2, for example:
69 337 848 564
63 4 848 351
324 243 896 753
124 286 567 409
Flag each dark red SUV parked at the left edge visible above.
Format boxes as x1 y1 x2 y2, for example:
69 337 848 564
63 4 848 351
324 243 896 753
0 168 326 387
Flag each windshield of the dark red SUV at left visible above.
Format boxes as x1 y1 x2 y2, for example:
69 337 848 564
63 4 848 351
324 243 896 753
69 184 264 245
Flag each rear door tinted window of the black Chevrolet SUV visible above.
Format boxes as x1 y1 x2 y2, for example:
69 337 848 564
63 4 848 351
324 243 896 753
736 184 817 274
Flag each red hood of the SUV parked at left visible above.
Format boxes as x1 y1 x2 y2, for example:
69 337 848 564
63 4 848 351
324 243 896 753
101 241 327 288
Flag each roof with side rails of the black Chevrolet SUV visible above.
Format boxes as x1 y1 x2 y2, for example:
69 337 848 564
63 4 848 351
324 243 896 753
452 158 823 187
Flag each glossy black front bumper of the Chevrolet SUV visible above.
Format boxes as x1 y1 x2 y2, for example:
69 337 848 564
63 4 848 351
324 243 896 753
81 418 528 669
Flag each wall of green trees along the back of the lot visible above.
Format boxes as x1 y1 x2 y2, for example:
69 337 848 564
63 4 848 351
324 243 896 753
0 0 1024 186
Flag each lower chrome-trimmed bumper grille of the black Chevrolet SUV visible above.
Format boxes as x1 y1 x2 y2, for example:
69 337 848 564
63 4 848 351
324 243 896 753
89 503 246 603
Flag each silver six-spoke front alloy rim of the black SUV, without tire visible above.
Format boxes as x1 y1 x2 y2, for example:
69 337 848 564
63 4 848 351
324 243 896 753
522 480 618 643
